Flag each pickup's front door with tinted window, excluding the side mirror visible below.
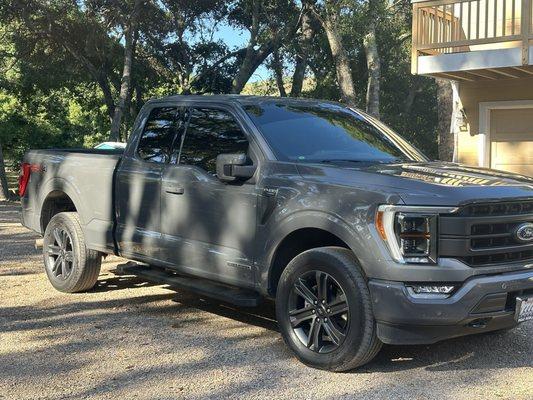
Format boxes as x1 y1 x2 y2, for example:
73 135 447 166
161 106 257 286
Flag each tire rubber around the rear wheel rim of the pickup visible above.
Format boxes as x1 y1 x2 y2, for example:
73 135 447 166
43 213 84 292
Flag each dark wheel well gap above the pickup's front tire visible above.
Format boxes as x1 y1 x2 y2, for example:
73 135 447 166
268 228 350 295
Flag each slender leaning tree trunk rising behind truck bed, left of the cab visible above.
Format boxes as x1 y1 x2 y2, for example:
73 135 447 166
109 0 142 142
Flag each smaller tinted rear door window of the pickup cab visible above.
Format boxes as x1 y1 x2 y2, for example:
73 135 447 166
137 107 183 163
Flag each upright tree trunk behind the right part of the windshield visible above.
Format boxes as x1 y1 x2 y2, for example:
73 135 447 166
363 22 381 118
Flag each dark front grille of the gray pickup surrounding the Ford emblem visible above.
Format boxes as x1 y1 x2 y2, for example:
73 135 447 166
439 200 533 267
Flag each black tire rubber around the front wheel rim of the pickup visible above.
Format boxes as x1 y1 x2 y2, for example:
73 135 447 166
276 249 373 369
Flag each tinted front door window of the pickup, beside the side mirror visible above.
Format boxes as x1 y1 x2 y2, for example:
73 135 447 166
180 108 248 174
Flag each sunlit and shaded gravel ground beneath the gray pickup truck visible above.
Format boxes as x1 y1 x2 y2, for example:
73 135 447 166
0 203 533 400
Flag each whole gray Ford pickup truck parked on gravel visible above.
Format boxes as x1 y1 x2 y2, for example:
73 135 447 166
19 96 533 371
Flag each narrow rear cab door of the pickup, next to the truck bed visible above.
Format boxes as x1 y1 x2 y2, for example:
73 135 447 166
115 106 184 262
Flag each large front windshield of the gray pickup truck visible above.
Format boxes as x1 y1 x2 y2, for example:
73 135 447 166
244 101 427 163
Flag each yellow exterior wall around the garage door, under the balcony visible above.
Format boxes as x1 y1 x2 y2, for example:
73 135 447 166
457 76 533 165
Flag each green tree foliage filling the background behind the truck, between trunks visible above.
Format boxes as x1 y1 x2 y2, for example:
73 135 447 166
0 0 437 160
